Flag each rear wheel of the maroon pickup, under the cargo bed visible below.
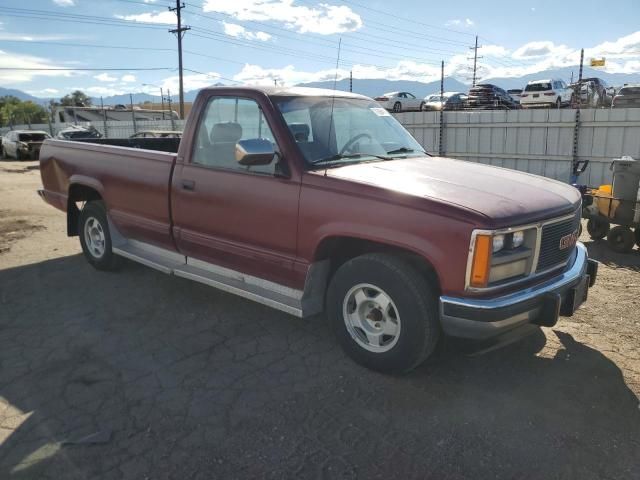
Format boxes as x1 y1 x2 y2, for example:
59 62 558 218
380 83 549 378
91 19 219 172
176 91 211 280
78 201 120 271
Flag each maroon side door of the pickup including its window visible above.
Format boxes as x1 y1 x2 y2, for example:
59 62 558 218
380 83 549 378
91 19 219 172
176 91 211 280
171 96 300 285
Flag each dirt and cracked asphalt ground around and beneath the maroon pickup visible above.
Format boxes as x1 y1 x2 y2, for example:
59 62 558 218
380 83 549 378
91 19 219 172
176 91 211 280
0 162 640 479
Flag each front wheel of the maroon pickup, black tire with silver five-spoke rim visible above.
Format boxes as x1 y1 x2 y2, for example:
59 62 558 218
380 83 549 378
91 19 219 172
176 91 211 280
326 253 440 373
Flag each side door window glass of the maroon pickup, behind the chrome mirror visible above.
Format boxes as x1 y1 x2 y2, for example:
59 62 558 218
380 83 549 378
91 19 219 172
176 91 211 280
192 97 277 175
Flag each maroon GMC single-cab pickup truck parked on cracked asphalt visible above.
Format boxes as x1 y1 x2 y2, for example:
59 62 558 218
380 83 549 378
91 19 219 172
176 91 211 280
39 87 597 372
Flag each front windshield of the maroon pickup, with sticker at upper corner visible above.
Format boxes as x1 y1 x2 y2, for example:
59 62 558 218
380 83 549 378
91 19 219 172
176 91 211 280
275 96 425 167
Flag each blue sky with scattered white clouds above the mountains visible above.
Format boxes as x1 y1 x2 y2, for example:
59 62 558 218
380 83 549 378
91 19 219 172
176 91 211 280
0 0 640 97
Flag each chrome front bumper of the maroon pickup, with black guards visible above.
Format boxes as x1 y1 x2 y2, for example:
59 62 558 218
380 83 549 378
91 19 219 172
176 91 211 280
440 243 598 340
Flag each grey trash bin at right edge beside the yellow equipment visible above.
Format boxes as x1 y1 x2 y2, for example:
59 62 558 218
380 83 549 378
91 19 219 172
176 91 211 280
611 156 640 224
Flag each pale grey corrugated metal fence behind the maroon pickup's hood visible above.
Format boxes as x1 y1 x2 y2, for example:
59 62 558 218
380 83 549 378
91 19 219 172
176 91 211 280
395 108 640 186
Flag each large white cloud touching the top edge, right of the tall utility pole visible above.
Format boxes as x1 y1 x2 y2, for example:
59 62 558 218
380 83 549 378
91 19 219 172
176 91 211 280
202 0 362 35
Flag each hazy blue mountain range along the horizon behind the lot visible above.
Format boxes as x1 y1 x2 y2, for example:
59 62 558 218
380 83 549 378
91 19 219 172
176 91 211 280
0 66 640 105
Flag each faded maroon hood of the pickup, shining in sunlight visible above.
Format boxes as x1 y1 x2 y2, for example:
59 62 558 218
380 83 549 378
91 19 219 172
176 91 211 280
321 157 580 227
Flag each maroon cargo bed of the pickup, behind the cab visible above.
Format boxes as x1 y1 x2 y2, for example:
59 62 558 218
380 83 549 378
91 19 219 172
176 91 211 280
40 138 179 249
